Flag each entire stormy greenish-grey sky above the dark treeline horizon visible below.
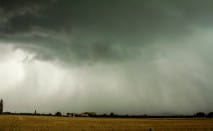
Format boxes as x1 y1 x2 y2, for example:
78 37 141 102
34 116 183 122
0 0 213 114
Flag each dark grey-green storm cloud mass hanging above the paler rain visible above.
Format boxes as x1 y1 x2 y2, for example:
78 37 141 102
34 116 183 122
1 0 212 63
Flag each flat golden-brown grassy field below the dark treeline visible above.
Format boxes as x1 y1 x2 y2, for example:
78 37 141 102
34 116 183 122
0 115 213 131
